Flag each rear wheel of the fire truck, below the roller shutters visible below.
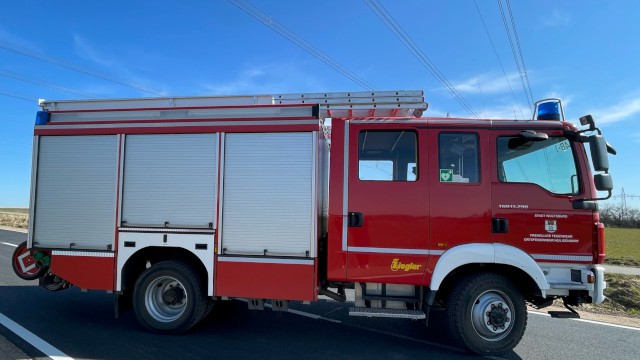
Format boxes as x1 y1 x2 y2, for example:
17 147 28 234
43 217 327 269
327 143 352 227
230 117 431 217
133 261 207 333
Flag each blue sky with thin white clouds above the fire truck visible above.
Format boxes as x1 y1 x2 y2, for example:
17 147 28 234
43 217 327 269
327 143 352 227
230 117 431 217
0 0 640 207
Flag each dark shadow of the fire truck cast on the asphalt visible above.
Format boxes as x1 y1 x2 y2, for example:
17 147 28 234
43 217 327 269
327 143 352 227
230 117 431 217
0 286 519 359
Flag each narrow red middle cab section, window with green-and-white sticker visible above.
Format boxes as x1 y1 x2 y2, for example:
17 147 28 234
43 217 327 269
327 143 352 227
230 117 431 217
425 126 491 284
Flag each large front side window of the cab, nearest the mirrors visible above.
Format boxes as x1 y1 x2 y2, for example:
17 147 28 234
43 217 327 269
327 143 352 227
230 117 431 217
498 136 579 194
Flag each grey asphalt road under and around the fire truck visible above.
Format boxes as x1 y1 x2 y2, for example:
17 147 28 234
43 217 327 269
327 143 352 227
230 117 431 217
0 230 640 360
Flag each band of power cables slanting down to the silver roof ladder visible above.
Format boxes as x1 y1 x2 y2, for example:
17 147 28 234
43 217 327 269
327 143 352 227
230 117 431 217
227 0 375 90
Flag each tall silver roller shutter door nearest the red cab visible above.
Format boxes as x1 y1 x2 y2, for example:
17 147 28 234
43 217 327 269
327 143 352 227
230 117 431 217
222 133 314 256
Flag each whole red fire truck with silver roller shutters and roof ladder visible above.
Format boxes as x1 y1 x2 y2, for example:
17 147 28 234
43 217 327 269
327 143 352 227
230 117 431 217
13 91 615 354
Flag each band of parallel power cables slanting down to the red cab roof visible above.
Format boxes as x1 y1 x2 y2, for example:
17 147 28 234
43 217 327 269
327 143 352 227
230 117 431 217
364 0 480 118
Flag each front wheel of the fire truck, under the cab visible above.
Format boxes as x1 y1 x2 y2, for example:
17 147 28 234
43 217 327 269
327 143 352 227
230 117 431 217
447 273 527 355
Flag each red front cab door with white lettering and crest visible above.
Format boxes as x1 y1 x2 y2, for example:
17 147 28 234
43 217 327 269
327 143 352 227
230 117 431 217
491 130 593 263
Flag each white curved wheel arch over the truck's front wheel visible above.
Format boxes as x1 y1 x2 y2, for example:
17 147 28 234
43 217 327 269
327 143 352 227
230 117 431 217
428 244 549 304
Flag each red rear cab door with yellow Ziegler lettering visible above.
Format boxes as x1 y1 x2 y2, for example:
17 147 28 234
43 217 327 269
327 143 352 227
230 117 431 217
347 120 429 284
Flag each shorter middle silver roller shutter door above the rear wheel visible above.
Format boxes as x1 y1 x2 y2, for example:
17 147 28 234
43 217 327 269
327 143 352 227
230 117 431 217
122 134 217 228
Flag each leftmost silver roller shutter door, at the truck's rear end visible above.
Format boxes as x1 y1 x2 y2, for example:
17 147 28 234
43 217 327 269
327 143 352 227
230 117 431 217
33 136 118 250
